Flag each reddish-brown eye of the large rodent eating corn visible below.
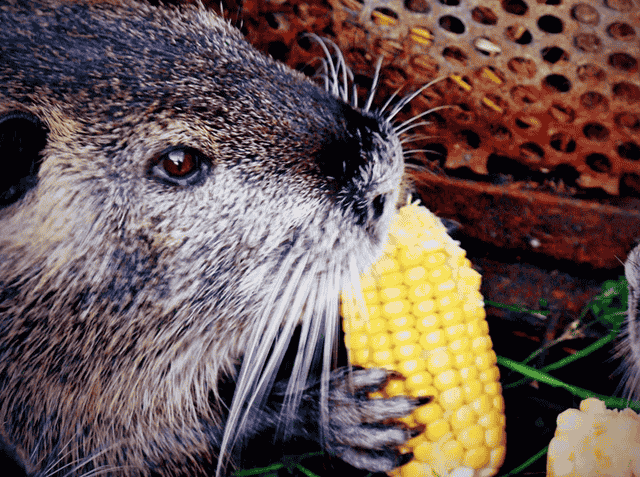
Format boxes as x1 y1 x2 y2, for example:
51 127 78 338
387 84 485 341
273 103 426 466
151 147 209 186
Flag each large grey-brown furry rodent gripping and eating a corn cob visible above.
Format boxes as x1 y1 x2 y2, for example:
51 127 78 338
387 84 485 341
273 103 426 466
0 0 426 476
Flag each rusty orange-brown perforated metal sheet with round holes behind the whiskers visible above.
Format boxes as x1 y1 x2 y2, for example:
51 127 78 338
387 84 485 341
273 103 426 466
331 0 640 194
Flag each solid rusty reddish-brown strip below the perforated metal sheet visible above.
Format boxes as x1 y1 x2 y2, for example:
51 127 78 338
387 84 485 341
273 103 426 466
416 173 640 268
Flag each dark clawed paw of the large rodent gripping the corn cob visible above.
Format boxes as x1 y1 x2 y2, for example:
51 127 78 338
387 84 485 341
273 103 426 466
326 368 431 472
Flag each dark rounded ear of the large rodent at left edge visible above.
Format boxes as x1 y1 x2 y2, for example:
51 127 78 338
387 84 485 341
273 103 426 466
0 111 49 208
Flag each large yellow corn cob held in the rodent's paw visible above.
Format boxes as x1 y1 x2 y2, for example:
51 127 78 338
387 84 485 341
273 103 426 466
342 204 506 477
